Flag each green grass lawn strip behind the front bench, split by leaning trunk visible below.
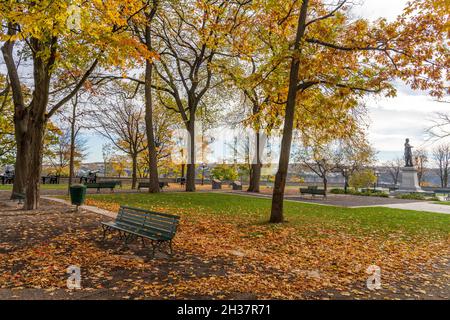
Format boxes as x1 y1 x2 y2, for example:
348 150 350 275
88 192 450 237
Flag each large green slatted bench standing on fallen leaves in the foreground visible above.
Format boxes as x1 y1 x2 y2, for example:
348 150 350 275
102 206 180 256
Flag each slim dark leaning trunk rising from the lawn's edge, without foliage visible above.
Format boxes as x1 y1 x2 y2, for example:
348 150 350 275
270 0 308 223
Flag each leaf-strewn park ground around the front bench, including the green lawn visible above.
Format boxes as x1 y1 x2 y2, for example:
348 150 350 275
0 193 450 299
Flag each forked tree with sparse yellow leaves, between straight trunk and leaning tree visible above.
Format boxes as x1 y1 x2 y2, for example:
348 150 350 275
149 0 250 191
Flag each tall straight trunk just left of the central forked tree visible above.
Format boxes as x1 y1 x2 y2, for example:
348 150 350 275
145 23 160 193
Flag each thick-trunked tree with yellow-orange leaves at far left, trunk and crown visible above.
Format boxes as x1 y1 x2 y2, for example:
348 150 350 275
0 0 151 209
